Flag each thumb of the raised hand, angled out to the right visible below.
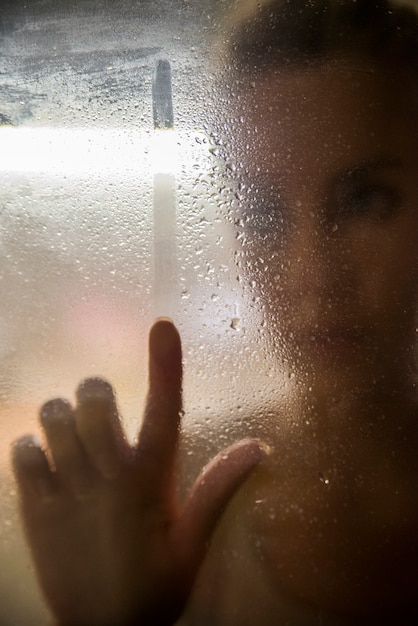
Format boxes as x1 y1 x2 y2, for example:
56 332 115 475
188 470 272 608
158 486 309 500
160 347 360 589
175 439 269 567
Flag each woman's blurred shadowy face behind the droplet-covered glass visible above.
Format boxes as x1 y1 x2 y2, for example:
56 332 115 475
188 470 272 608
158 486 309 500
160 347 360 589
232 60 418 384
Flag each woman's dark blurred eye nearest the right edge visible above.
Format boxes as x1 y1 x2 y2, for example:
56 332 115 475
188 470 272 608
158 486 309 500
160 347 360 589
337 185 402 220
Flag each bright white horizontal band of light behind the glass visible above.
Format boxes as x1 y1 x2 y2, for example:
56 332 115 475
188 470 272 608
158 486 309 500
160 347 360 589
0 126 208 179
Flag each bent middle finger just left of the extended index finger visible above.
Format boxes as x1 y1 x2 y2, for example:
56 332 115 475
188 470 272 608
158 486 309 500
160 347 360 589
76 378 127 480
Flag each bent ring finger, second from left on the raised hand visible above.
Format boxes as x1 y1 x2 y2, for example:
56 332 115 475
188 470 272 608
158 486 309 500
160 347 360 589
40 398 92 498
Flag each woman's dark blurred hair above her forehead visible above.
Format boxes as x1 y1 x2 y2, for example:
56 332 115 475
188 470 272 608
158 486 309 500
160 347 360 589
207 0 418 160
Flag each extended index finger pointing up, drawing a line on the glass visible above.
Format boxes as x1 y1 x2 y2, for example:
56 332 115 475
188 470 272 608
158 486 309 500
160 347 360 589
137 319 182 495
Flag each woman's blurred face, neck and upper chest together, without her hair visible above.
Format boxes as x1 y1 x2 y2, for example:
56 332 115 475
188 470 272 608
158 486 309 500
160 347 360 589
227 60 418 613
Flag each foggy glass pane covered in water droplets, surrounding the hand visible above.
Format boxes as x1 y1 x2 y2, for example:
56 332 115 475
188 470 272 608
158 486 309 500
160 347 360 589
0 0 418 626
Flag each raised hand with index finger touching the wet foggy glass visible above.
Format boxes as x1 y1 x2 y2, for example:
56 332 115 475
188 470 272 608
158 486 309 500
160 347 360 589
14 320 264 626
